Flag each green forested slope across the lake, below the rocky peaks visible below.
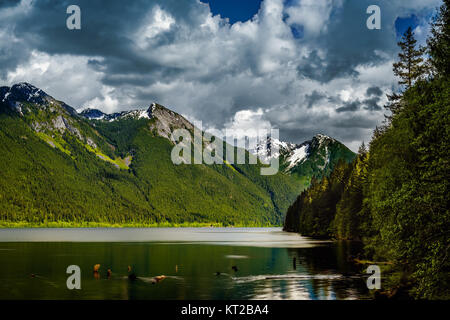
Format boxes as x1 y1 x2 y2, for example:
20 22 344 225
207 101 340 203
0 113 300 225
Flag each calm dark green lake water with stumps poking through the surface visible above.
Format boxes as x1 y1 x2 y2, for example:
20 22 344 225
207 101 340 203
0 228 368 299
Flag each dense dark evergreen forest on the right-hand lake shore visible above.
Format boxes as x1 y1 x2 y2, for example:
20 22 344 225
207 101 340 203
284 0 450 299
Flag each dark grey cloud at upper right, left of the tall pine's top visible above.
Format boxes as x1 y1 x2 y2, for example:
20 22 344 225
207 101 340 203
286 0 396 82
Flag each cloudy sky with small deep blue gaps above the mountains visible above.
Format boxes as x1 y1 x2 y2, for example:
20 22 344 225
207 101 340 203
0 0 441 151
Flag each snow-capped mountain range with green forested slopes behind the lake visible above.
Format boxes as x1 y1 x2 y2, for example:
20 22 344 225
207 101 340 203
0 83 355 226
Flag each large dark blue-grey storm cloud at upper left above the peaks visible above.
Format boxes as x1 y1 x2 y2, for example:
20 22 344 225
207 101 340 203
0 0 206 85
